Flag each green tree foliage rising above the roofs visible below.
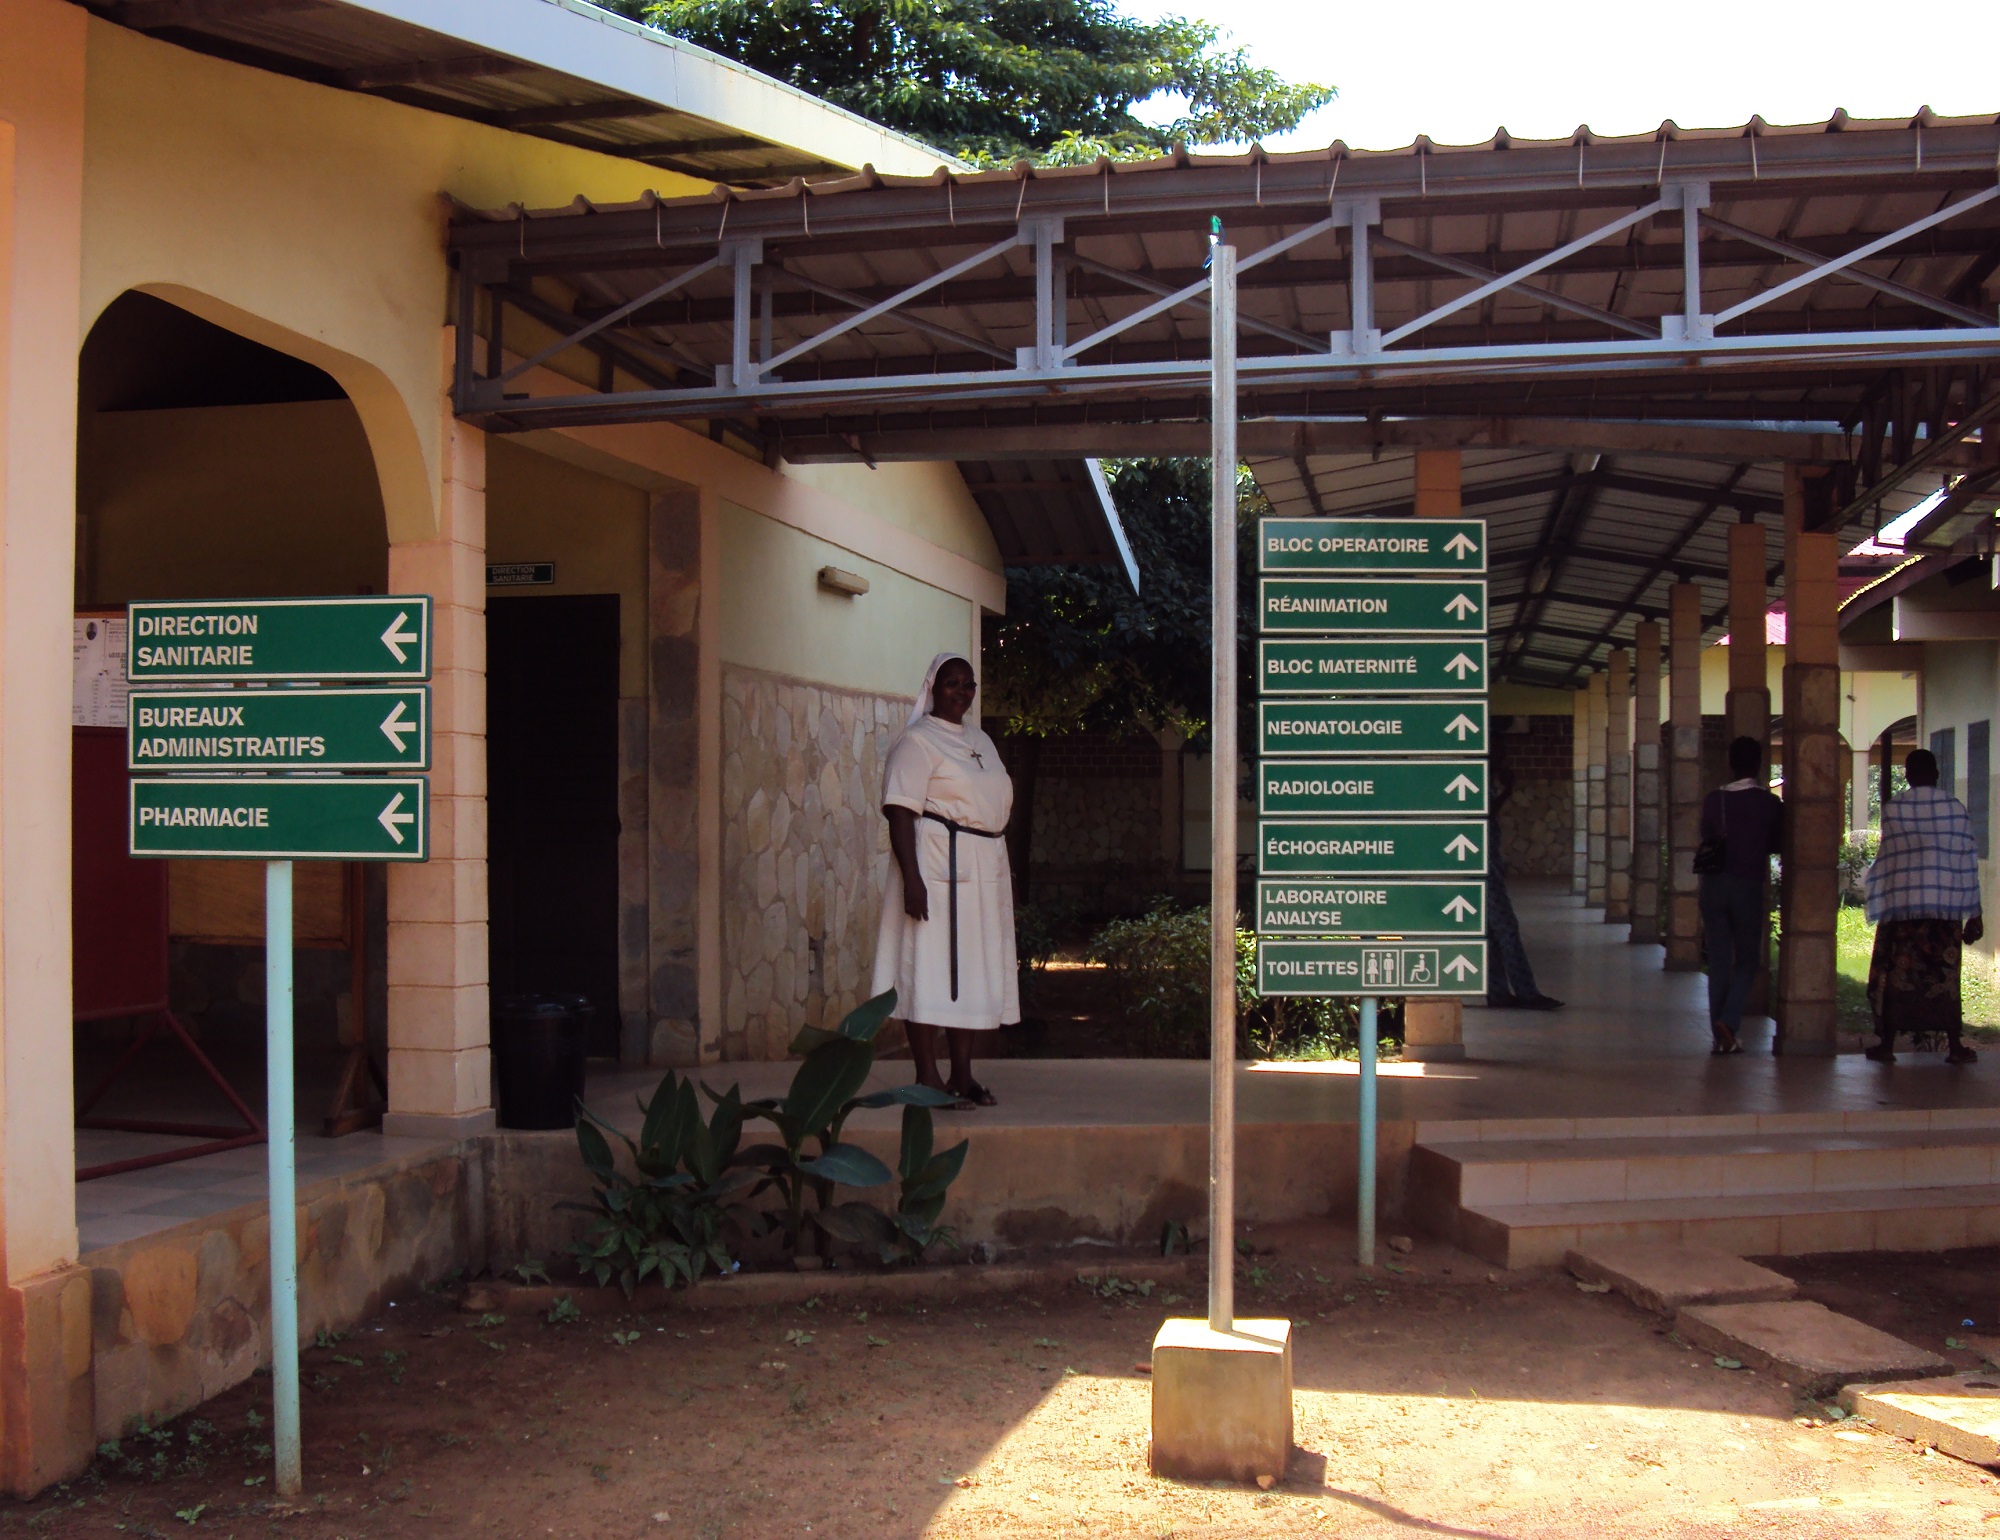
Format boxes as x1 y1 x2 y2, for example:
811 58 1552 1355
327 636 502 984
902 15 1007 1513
612 0 1334 164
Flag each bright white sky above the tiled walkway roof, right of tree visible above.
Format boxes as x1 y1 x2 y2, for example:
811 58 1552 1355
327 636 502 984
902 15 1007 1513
1120 0 2000 150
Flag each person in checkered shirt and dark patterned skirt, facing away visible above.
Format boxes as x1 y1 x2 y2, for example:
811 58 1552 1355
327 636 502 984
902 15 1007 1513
1868 748 1984 1064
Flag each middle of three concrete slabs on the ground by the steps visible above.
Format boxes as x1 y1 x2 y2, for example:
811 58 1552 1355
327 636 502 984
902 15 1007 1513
1674 1300 1952 1396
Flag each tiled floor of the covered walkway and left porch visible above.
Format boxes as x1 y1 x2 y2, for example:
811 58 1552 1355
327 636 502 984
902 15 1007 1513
76 884 2000 1250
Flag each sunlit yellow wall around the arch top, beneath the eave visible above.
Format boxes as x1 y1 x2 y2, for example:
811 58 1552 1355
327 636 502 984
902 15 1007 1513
76 20 708 540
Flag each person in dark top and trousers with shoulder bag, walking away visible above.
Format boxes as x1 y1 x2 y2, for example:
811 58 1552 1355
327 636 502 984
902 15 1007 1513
1702 738 1784 1054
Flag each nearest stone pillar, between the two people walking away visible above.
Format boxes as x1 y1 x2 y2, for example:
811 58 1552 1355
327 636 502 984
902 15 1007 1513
1774 466 1844 1054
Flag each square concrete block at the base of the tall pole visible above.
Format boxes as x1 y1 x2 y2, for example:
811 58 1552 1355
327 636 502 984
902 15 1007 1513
1152 1318 1292 1486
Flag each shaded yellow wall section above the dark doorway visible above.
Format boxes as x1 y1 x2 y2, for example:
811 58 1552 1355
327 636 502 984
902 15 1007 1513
486 438 648 696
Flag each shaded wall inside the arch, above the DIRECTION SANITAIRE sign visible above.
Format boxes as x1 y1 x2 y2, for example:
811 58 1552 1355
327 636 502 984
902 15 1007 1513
76 402 388 606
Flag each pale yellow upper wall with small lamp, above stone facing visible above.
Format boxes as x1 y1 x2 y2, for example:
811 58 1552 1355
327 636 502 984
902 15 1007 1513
718 502 978 696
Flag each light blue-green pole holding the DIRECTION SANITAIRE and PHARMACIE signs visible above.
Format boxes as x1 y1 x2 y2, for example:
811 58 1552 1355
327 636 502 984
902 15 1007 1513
264 860 304 1498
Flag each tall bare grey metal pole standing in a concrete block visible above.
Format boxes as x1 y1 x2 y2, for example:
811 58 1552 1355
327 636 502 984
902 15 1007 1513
1208 234 1236 1332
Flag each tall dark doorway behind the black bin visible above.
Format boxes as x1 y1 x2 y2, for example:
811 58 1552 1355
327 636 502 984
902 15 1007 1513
486 594 618 1054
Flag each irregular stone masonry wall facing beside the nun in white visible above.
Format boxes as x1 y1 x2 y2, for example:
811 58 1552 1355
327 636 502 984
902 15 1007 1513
722 666 910 1060
